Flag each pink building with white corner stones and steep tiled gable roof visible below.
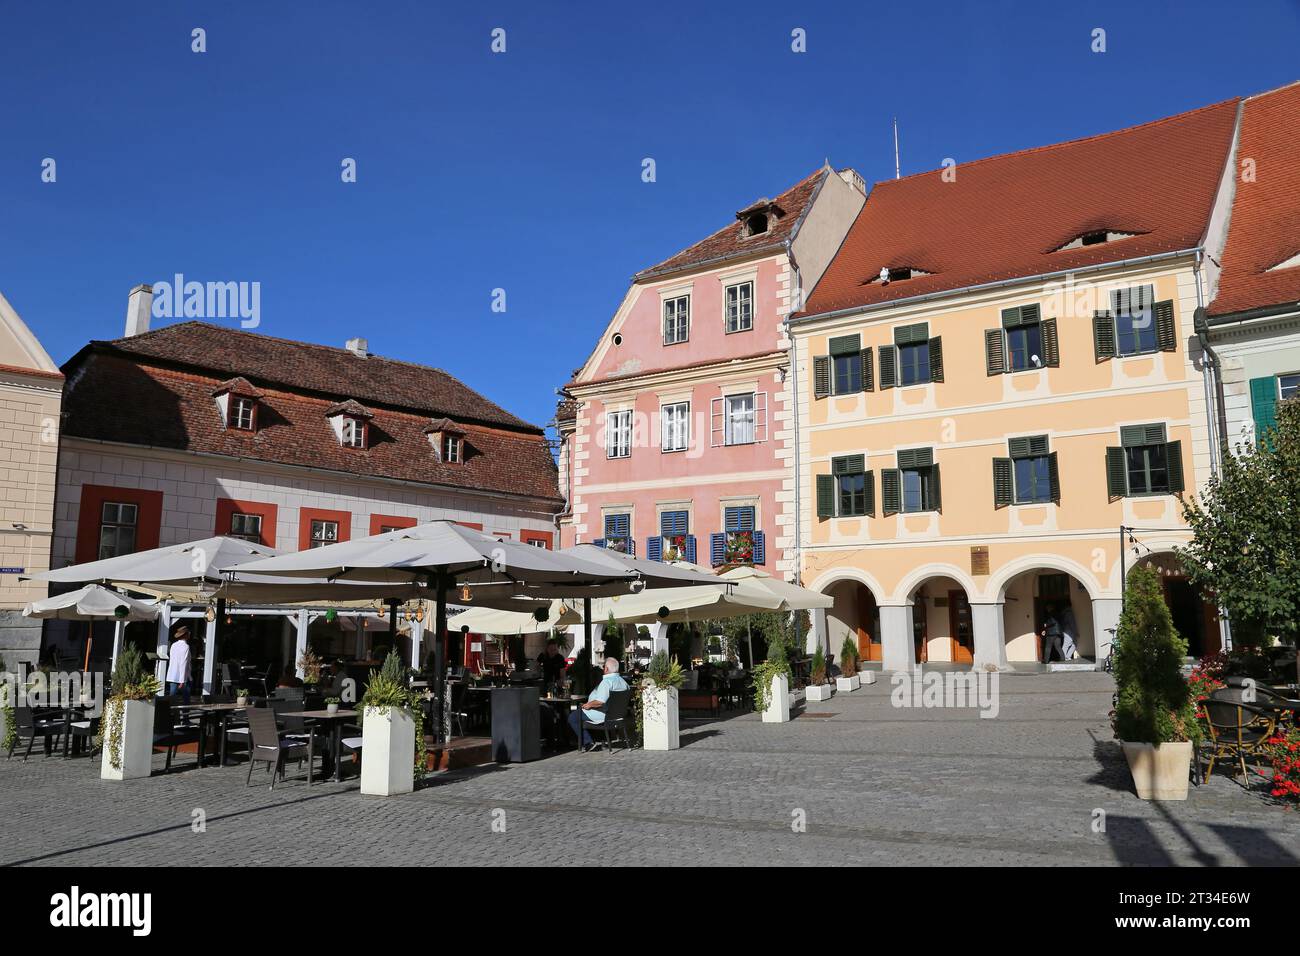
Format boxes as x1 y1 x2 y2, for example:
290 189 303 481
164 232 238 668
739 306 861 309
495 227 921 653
556 166 865 576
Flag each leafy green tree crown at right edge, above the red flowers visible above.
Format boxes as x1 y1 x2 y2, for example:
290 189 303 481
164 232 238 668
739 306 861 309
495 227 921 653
1179 399 1300 643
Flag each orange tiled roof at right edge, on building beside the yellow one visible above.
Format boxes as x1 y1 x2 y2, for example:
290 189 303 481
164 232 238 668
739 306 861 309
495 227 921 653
1209 83 1300 315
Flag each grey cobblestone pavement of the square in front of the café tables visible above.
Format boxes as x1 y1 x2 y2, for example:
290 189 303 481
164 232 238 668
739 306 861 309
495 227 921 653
0 674 1300 865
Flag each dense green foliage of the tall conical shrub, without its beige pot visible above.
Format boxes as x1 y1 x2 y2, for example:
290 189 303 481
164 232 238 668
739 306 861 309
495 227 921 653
1115 567 1200 744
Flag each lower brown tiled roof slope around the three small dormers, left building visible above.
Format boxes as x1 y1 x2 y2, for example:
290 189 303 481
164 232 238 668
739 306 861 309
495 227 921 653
64 351 560 501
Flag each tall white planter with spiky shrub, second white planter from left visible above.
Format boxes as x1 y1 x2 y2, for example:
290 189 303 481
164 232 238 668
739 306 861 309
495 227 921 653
361 652 424 796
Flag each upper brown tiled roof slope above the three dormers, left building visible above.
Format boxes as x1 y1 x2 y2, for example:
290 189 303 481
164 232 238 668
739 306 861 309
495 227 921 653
87 321 541 433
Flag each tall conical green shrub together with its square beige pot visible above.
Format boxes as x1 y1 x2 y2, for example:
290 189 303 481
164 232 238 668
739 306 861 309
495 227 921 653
1114 567 1201 800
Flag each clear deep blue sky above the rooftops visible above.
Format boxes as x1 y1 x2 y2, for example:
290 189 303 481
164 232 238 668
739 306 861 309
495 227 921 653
0 0 1300 423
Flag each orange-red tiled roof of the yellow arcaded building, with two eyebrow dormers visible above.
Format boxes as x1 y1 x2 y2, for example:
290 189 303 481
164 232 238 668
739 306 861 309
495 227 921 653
803 100 1238 315
